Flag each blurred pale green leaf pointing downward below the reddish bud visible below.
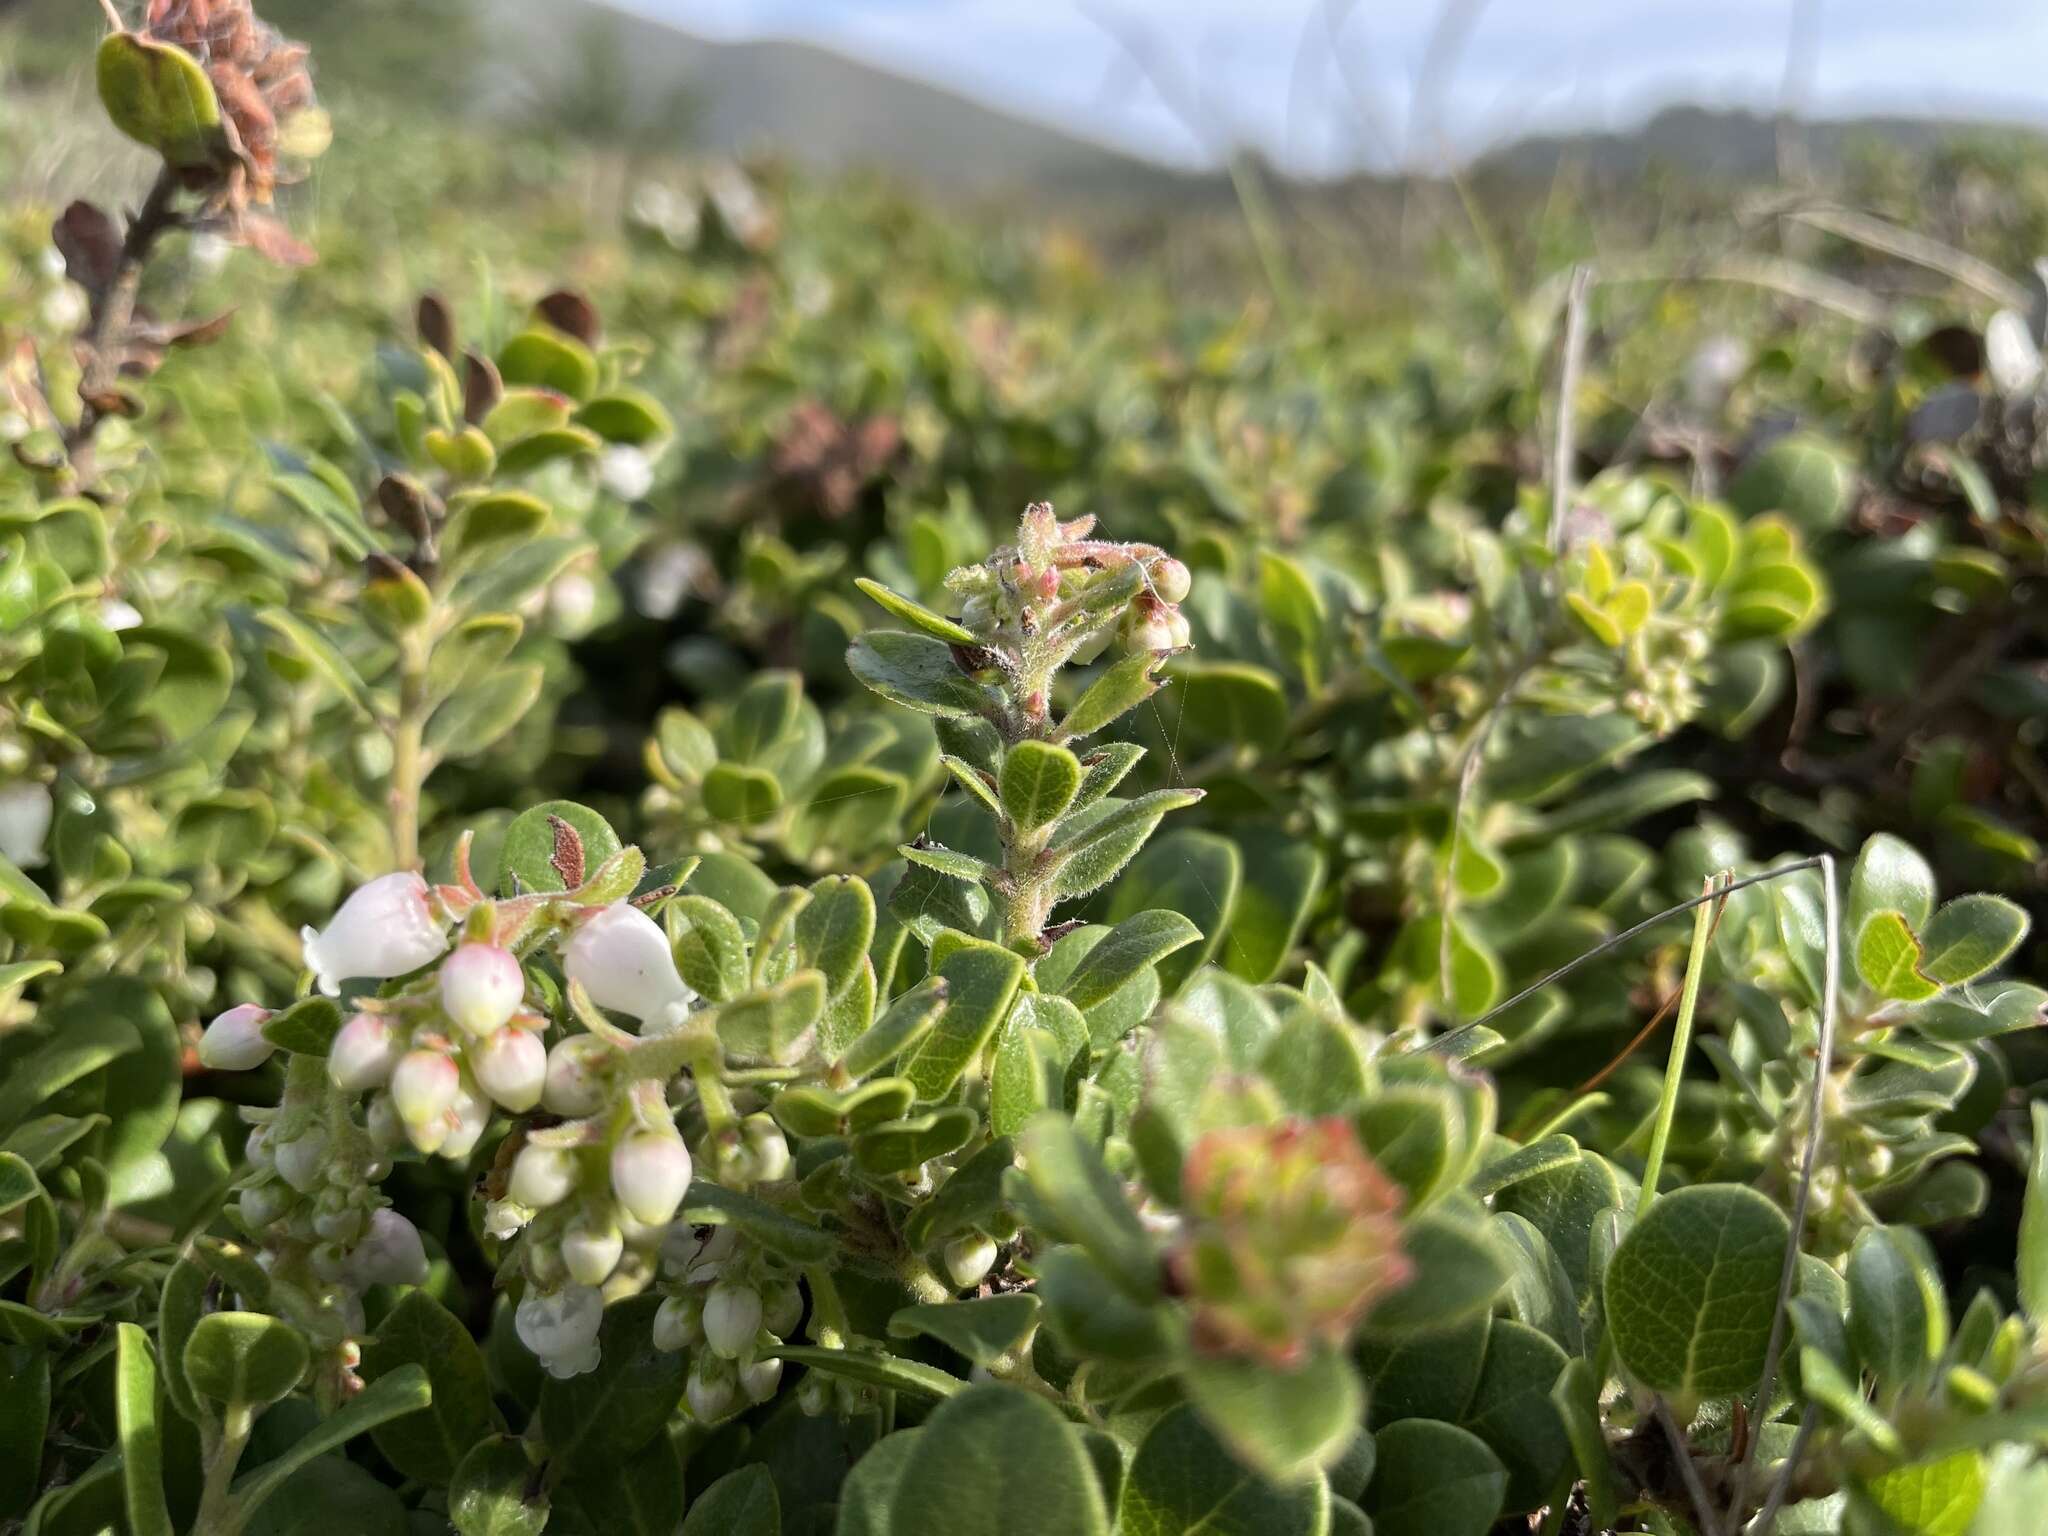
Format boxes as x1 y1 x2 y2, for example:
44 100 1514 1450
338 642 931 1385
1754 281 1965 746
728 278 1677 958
1182 1348 1366 1483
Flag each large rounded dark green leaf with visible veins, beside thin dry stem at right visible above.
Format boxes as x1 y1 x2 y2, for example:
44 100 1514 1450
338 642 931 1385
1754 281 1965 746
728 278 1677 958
1606 1184 1790 1419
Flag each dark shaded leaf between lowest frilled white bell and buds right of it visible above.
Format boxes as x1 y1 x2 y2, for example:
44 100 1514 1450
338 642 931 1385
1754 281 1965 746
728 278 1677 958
541 1302 694 1475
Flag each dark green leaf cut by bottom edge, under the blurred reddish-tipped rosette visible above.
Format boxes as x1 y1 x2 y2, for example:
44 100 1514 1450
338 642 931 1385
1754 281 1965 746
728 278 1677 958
1116 1407 1329 1536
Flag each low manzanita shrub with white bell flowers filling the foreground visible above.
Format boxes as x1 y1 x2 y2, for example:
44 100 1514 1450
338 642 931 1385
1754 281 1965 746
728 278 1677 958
12 0 2048 1536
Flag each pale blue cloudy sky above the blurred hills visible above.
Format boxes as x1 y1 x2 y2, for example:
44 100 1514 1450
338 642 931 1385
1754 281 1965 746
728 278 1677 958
614 0 2048 172
